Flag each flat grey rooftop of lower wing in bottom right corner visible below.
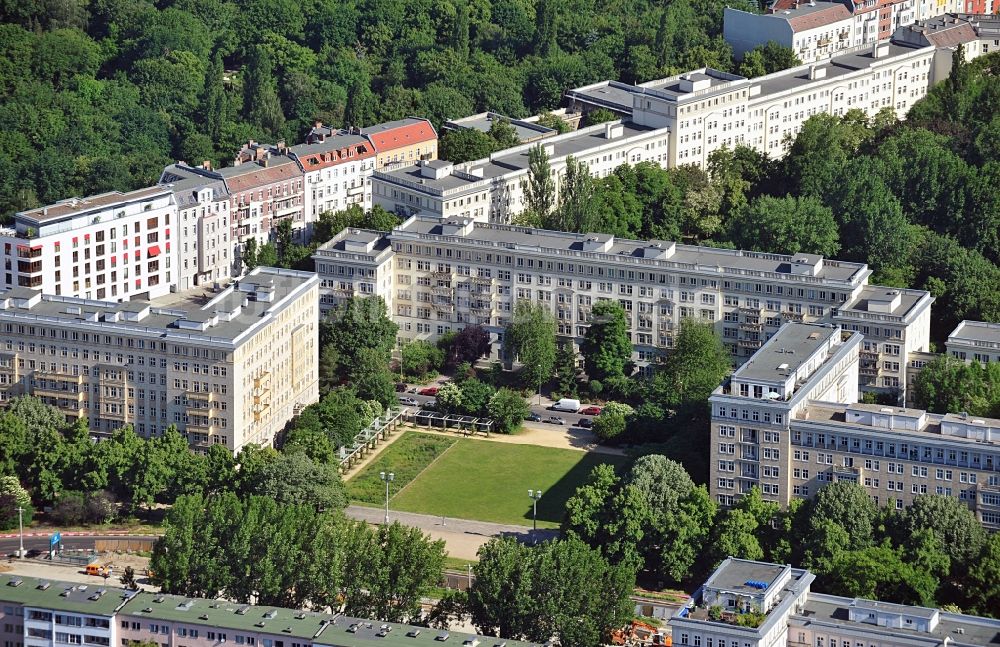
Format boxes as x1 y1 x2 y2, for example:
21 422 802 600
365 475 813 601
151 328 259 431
792 593 1000 647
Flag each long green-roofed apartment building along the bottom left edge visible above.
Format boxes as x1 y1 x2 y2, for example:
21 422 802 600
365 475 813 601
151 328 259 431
0 575 530 647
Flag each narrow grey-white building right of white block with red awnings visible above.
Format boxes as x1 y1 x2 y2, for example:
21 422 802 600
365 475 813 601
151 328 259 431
160 164 233 291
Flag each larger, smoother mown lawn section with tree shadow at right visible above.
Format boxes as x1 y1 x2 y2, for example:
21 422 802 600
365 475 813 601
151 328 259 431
388 438 628 528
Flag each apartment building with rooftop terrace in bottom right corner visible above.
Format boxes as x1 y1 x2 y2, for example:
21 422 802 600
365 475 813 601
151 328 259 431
668 557 1000 647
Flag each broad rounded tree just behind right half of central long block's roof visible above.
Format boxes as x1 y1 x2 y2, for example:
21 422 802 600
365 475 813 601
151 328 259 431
728 196 840 257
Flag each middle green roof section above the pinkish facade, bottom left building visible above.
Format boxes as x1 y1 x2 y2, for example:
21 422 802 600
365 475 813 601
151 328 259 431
121 592 333 640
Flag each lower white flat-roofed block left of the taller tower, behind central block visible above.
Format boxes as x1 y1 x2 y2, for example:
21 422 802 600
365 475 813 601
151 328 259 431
372 122 669 223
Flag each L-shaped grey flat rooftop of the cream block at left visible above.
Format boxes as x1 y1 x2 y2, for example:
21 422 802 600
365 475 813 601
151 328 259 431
0 267 319 343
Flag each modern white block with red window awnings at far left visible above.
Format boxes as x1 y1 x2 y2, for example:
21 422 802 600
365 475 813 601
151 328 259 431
0 186 177 301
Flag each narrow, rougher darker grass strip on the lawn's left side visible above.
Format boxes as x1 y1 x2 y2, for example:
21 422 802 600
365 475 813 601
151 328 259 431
347 431 458 505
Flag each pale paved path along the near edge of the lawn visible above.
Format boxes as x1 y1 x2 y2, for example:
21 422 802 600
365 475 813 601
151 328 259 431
344 505 559 559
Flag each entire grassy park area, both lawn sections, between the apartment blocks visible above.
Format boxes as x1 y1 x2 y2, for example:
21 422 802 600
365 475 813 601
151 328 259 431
347 431 629 528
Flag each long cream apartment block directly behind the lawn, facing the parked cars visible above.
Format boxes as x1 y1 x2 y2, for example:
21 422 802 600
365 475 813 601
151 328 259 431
313 215 933 388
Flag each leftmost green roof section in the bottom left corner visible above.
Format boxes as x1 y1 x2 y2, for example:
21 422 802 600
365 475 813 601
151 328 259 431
0 575 129 616
